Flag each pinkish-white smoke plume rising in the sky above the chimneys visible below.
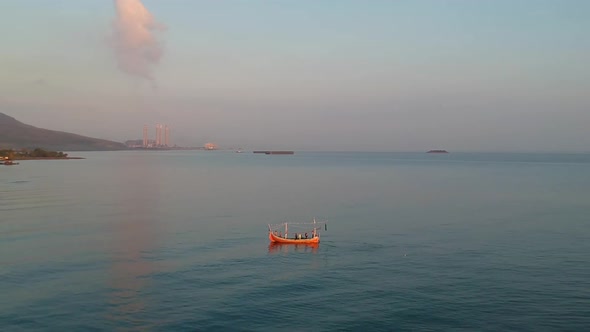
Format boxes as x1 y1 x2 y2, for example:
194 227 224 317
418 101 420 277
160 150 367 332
112 0 164 80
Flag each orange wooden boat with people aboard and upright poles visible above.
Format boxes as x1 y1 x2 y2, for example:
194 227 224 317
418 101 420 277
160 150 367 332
268 218 328 244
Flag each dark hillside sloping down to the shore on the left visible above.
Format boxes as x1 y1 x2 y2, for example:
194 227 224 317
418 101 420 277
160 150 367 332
0 113 127 151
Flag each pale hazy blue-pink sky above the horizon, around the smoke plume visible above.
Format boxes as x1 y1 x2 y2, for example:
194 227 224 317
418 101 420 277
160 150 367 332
0 0 590 152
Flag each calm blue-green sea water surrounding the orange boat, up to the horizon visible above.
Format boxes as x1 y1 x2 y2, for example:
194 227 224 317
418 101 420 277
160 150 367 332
0 151 590 331
